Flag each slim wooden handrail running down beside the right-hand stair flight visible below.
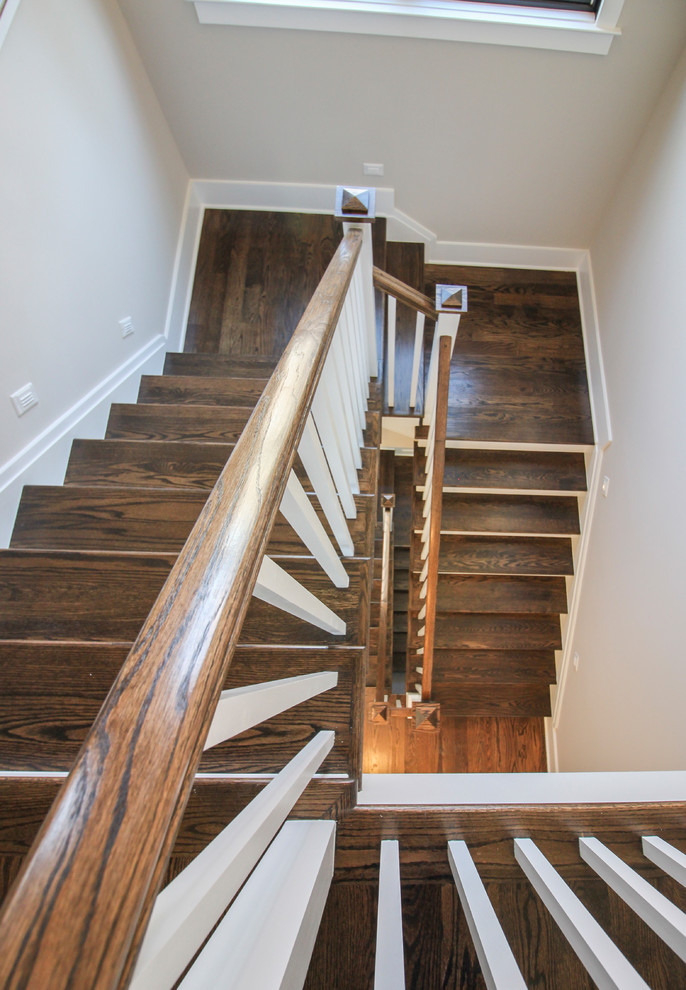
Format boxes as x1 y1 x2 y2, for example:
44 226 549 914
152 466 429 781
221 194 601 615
422 336 452 701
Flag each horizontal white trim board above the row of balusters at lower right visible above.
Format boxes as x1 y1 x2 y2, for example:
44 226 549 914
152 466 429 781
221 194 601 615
357 770 686 807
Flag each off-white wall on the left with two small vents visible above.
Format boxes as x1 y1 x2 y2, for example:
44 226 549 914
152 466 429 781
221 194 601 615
0 0 188 539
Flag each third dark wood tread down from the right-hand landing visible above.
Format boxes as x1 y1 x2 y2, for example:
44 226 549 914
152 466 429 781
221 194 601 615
424 534 574 575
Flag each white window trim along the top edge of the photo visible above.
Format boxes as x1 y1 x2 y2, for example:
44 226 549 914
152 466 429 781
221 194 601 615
188 0 624 55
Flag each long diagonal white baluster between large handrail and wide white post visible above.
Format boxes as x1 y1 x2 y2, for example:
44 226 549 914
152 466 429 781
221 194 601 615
130 732 334 990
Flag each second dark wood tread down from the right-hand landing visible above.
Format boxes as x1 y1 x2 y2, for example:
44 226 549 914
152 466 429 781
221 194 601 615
441 492 579 536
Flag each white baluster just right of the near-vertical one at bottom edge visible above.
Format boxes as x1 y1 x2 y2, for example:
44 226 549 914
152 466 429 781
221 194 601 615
448 842 526 990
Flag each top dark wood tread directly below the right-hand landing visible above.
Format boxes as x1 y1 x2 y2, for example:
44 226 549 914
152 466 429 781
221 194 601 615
444 448 586 492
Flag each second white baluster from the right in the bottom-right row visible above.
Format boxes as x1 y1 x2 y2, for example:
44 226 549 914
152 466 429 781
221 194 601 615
579 836 686 961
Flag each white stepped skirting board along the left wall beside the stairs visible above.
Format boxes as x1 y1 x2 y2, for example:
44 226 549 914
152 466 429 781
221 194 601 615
0 334 166 547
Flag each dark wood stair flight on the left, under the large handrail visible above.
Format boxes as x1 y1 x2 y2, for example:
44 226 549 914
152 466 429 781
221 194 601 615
0 346 380 895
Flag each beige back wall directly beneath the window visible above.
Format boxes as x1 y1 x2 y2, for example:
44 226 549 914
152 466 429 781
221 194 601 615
118 0 686 247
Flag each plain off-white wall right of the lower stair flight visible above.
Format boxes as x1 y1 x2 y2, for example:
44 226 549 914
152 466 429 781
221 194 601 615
558 42 686 770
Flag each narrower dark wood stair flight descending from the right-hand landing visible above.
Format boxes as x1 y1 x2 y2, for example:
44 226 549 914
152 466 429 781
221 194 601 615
408 446 586 718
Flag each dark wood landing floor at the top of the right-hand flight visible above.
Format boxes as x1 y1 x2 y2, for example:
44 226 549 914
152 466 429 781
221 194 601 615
425 265 593 444
